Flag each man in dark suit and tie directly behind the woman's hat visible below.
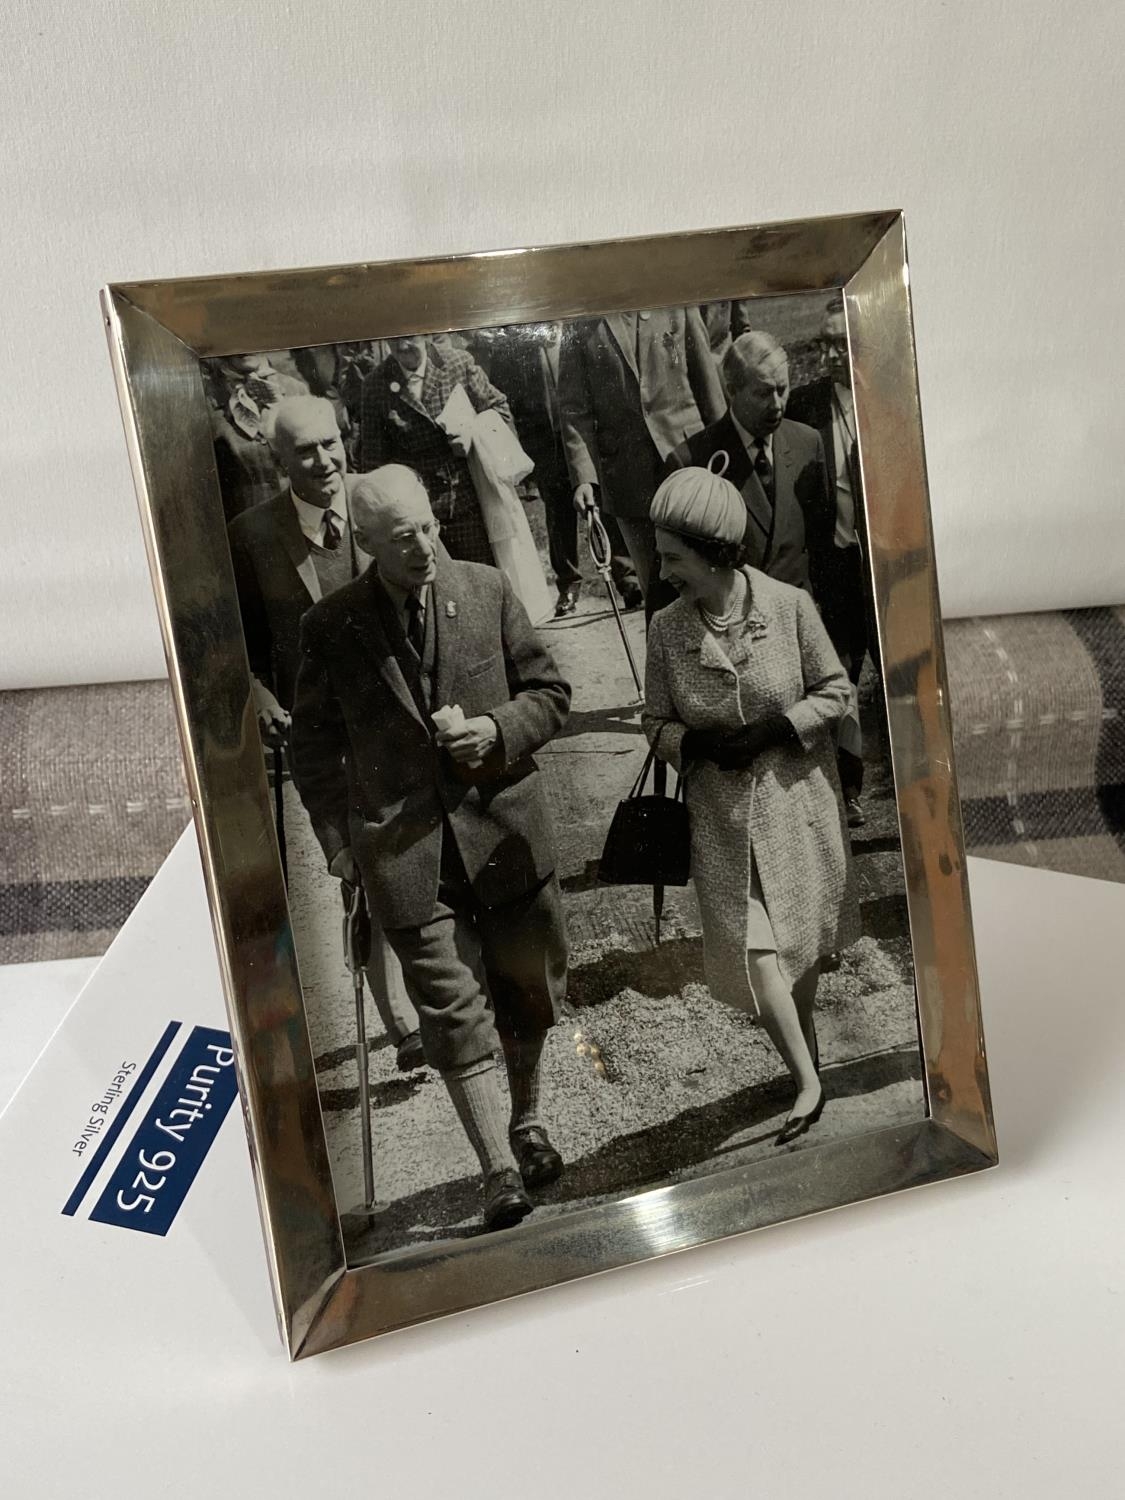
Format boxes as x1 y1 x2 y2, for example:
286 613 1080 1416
669 332 830 593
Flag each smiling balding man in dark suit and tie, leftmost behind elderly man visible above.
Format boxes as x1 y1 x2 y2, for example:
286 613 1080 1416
228 396 425 1073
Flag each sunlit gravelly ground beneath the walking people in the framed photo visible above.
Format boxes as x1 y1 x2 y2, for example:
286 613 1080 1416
287 588 924 1259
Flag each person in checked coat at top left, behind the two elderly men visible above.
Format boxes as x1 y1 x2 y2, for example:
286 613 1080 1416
359 336 512 564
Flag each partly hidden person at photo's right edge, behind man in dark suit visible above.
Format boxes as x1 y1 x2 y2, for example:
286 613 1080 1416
789 306 879 828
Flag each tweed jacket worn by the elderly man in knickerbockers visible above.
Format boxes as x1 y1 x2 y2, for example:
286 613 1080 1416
293 551 570 929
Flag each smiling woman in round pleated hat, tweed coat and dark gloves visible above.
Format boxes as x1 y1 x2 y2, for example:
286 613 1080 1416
644 468 860 1145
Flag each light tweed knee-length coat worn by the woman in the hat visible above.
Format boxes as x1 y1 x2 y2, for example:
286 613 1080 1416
644 569 860 1010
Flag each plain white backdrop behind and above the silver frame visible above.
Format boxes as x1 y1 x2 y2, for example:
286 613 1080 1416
0 0 1125 687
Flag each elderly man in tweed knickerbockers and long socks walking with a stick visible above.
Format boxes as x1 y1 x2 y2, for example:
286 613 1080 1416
293 464 570 1229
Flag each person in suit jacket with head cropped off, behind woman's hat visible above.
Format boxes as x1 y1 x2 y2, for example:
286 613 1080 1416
558 308 726 614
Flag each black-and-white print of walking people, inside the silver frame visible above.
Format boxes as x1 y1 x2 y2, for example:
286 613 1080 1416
203 293 926 1265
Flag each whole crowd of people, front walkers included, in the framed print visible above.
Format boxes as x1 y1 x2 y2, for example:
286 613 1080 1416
206 303 878 1229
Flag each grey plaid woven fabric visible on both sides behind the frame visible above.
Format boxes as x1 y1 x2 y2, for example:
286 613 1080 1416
0 608 1125 963
